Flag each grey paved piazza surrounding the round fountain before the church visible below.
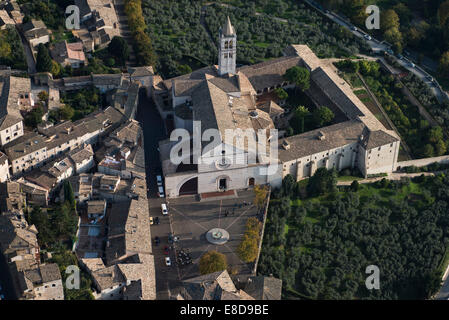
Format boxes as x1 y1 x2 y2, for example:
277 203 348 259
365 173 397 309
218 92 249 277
169 190 257 279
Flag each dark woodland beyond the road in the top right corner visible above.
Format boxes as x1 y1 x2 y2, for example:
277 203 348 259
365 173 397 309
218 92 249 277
318 0 449 76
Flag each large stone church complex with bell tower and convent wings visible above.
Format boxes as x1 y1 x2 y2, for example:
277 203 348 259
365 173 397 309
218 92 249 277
151 18 400 197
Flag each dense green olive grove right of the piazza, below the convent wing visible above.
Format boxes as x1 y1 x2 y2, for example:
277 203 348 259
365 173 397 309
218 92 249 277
258 172 449 299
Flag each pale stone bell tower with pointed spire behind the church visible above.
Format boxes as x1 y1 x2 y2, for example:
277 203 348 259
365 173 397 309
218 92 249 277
218 16 237 76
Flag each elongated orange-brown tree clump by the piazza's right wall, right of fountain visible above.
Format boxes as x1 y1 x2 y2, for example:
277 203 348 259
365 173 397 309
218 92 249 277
237 217 262 263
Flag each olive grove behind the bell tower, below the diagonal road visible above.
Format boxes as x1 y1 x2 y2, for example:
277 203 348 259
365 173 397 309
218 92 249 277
143 0 369 77
